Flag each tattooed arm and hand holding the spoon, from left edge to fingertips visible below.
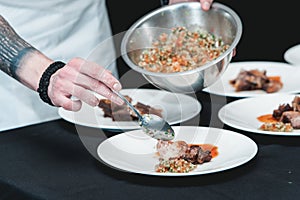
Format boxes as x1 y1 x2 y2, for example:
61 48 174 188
0 15 123 111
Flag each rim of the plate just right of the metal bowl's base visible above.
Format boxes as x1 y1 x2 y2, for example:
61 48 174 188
203 60 300 98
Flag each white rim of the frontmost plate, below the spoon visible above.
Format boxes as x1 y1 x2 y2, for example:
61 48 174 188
96 126 258 177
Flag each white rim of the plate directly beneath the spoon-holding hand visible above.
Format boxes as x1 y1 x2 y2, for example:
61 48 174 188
58 88 202 131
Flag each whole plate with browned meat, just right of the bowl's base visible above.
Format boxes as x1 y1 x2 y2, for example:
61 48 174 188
203 61 300 98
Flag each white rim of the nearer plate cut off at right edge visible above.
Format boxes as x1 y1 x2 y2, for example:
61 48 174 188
218 94 300 137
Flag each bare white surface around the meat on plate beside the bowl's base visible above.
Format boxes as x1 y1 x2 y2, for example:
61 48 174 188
203 61 300 97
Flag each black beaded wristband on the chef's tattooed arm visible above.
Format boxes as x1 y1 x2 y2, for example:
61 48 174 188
37 61 66 106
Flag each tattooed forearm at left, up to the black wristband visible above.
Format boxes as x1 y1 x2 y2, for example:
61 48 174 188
0 15 52 90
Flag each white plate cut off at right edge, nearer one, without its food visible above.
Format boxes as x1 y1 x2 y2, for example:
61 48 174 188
218 94 300 136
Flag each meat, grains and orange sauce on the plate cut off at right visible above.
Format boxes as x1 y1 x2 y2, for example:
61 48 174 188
257 96 300 132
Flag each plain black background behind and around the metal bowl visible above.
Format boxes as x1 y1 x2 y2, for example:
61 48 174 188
107 0 300 74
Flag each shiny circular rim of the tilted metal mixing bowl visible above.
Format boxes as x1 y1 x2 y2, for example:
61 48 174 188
121 2 242 77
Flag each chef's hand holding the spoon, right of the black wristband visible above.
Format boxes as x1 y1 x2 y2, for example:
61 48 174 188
48 58 123 111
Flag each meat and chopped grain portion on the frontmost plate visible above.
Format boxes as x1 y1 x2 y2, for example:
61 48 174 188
155 140 218 173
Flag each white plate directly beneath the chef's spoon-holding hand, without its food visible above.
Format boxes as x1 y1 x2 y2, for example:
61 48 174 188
58 89 202 131
